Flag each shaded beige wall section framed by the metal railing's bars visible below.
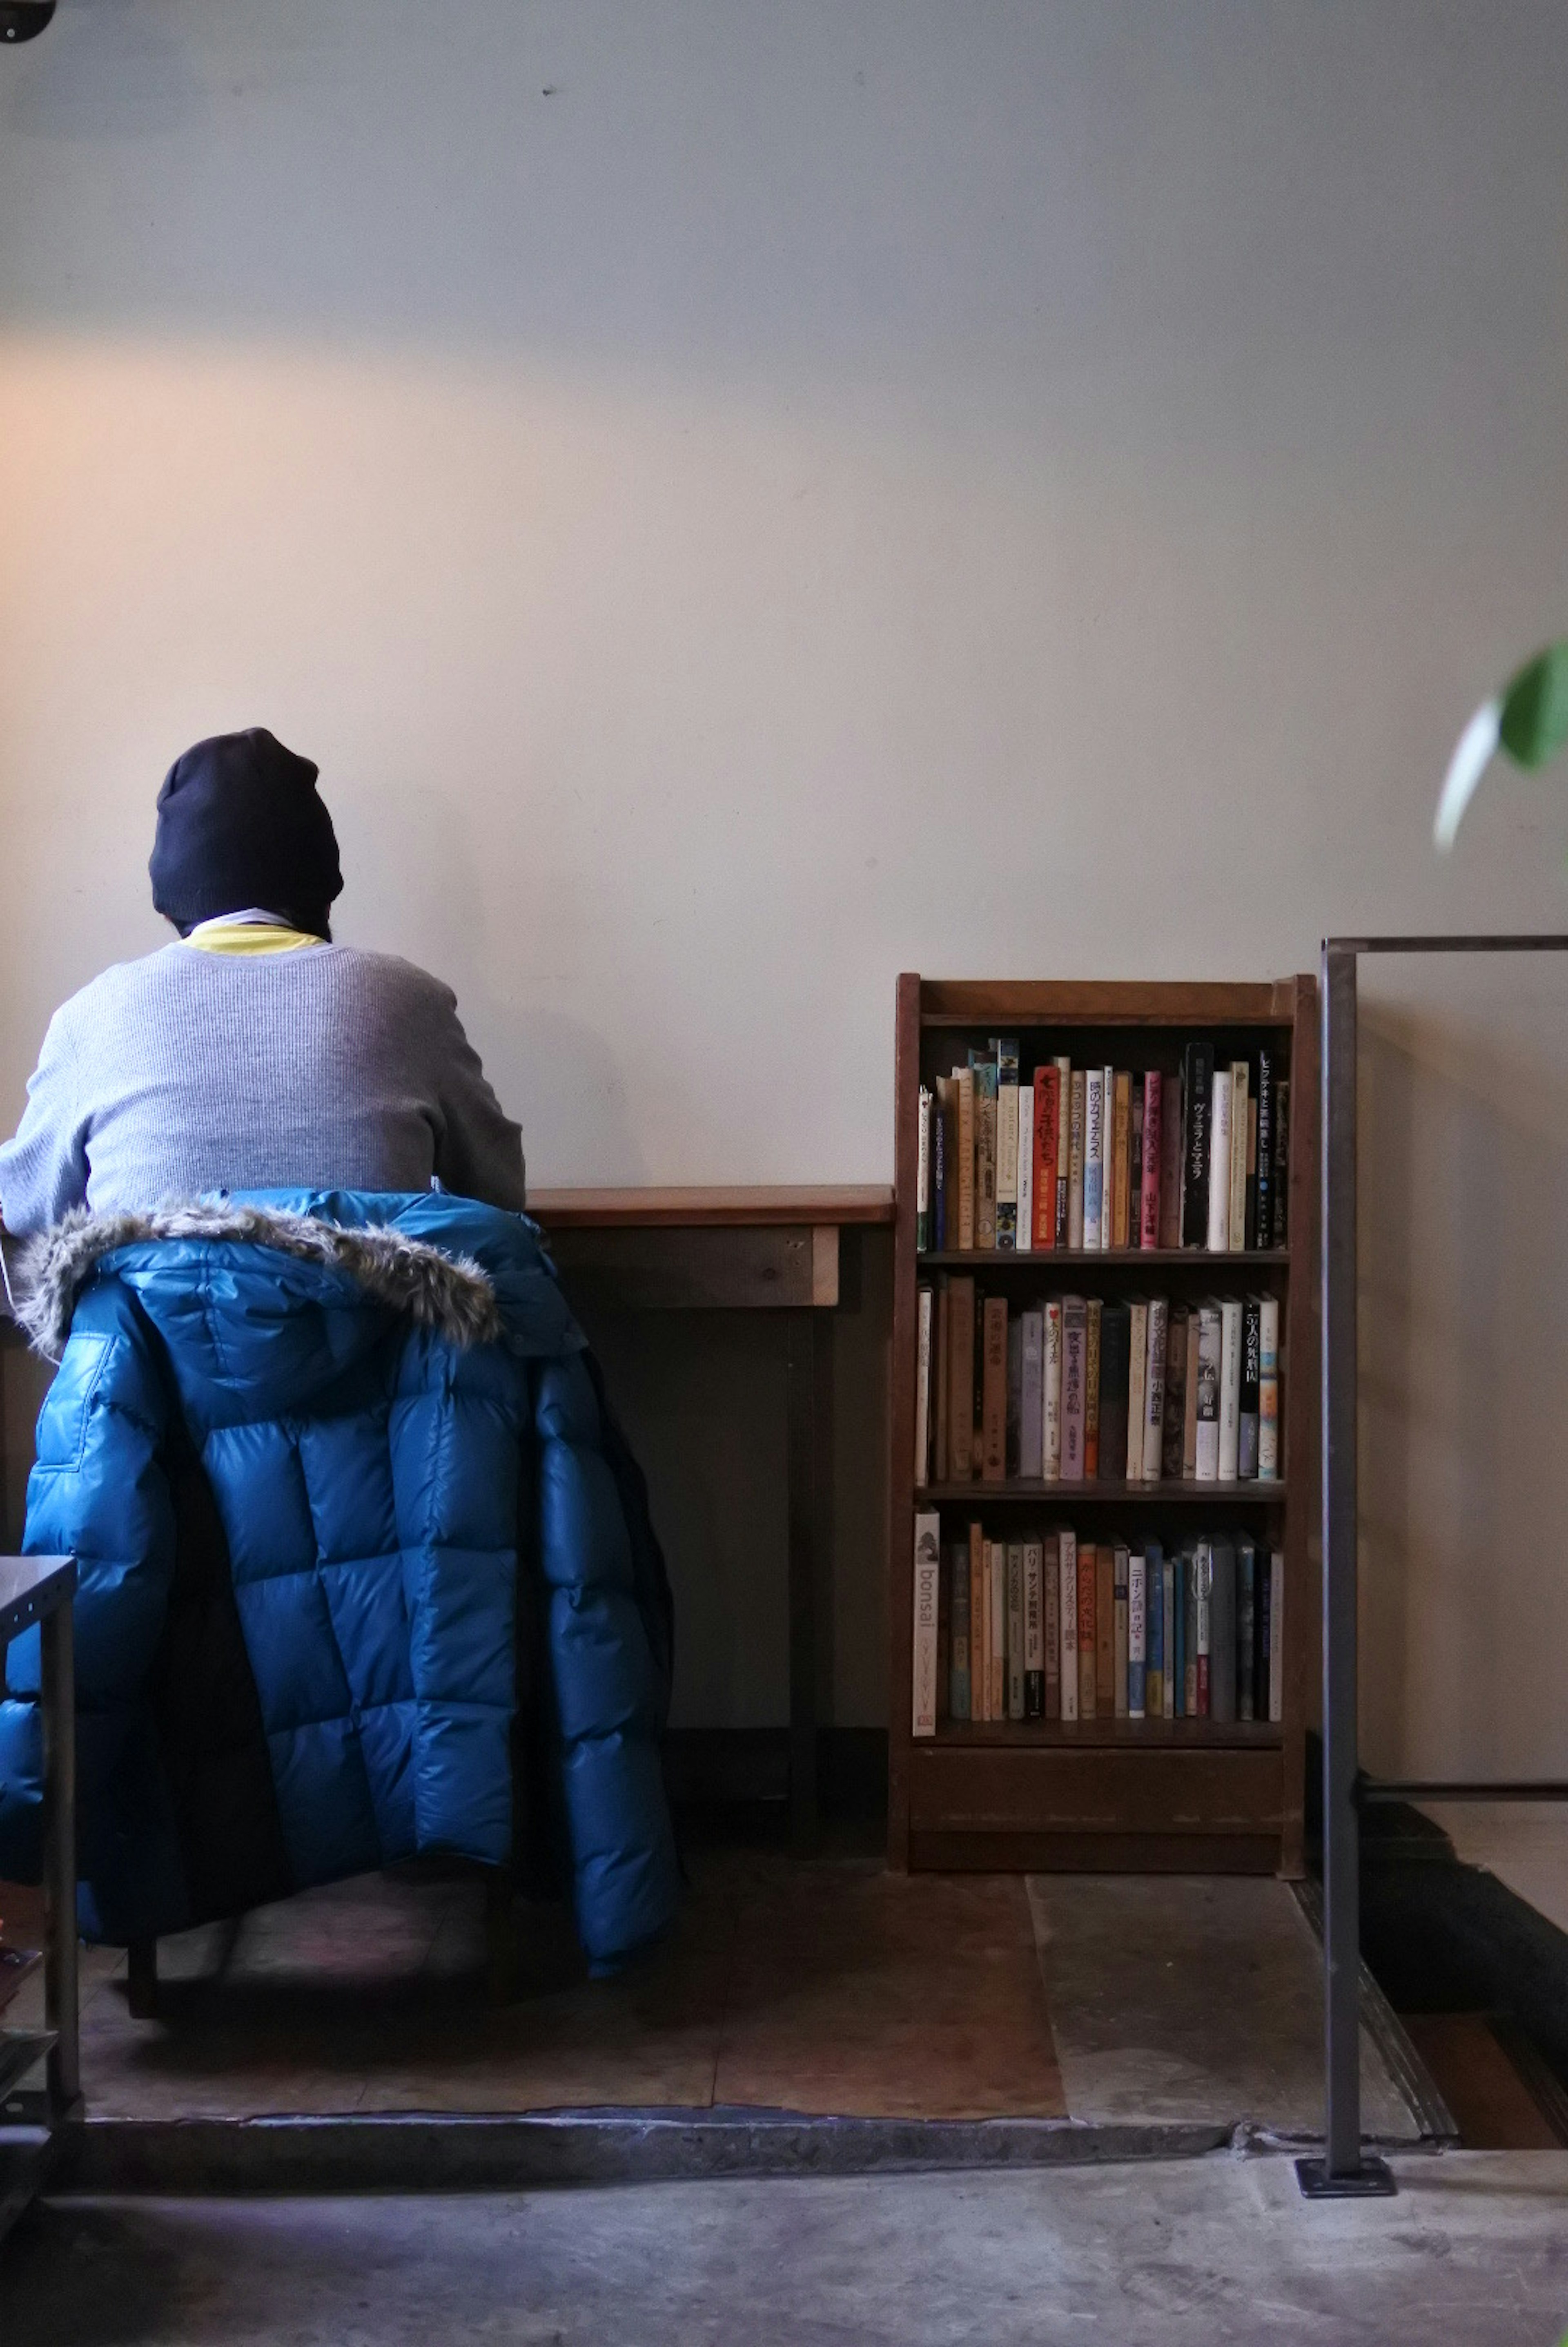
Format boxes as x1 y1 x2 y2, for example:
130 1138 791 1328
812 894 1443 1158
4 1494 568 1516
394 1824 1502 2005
1359 1004 1568 1777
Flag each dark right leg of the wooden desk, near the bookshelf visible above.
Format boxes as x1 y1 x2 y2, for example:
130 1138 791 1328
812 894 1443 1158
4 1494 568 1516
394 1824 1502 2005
788 1312 833 1852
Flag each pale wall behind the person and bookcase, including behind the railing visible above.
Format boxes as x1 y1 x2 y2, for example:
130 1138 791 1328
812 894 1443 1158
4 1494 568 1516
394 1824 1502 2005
0 0 1568 1767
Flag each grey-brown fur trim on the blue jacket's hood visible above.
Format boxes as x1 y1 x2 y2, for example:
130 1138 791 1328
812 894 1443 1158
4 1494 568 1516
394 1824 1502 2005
12 1199 502 1361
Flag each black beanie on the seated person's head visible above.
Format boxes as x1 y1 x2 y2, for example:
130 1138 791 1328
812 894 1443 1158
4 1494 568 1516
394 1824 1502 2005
148 725 343 934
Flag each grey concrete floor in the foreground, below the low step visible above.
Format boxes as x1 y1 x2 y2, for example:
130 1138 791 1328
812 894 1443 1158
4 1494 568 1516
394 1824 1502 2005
0 2152 1568 2347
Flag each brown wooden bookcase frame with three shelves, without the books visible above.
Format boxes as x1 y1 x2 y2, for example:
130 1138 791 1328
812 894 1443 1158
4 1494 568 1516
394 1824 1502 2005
887 976 1317 1875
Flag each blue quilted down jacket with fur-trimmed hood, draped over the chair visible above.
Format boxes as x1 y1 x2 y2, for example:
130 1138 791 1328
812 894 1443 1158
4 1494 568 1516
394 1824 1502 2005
0 1192 678 1967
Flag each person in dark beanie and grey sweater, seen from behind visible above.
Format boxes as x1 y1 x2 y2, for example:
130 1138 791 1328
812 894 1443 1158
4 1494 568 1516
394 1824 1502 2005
0 725 526 1237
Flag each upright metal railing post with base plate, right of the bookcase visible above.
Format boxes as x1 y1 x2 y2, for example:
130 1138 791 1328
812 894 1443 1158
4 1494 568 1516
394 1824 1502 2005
1296 939 1394 2199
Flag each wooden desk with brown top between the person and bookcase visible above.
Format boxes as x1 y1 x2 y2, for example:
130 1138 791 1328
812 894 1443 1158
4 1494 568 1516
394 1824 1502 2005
528 1183 892 1849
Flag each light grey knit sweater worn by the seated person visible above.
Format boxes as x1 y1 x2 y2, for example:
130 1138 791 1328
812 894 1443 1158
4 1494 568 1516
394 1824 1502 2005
0 944 523 1232
